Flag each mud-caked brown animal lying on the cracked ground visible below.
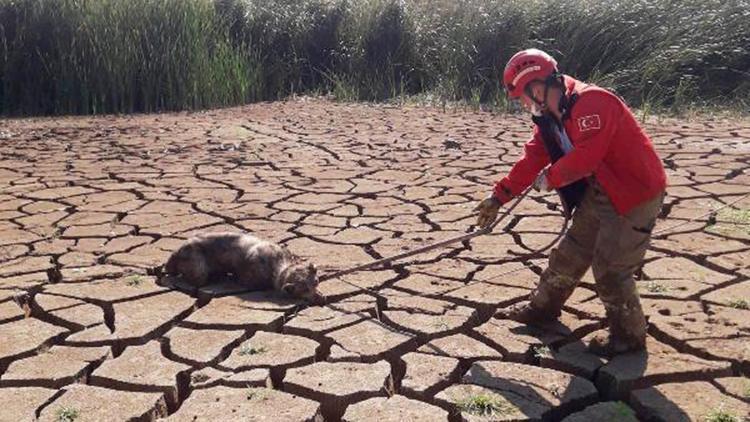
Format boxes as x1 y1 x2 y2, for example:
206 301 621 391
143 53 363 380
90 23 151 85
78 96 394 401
164 232 325 305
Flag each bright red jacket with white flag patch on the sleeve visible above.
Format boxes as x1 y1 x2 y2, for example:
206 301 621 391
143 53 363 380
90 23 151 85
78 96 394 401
494 75 667 215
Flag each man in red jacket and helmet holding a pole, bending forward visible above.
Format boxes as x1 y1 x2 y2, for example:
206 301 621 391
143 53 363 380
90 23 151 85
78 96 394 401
476 49 666 356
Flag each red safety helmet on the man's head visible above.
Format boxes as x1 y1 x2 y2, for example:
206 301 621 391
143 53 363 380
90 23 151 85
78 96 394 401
503 48 557 98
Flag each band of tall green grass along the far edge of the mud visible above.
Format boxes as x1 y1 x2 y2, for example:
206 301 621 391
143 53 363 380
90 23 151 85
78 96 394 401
0 0 750 115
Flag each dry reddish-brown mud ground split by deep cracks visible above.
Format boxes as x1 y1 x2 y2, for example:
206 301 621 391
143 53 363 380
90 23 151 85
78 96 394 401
0 100 750 421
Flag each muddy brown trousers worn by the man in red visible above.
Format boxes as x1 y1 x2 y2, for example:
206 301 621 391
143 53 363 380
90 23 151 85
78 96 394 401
530 181 664 344
